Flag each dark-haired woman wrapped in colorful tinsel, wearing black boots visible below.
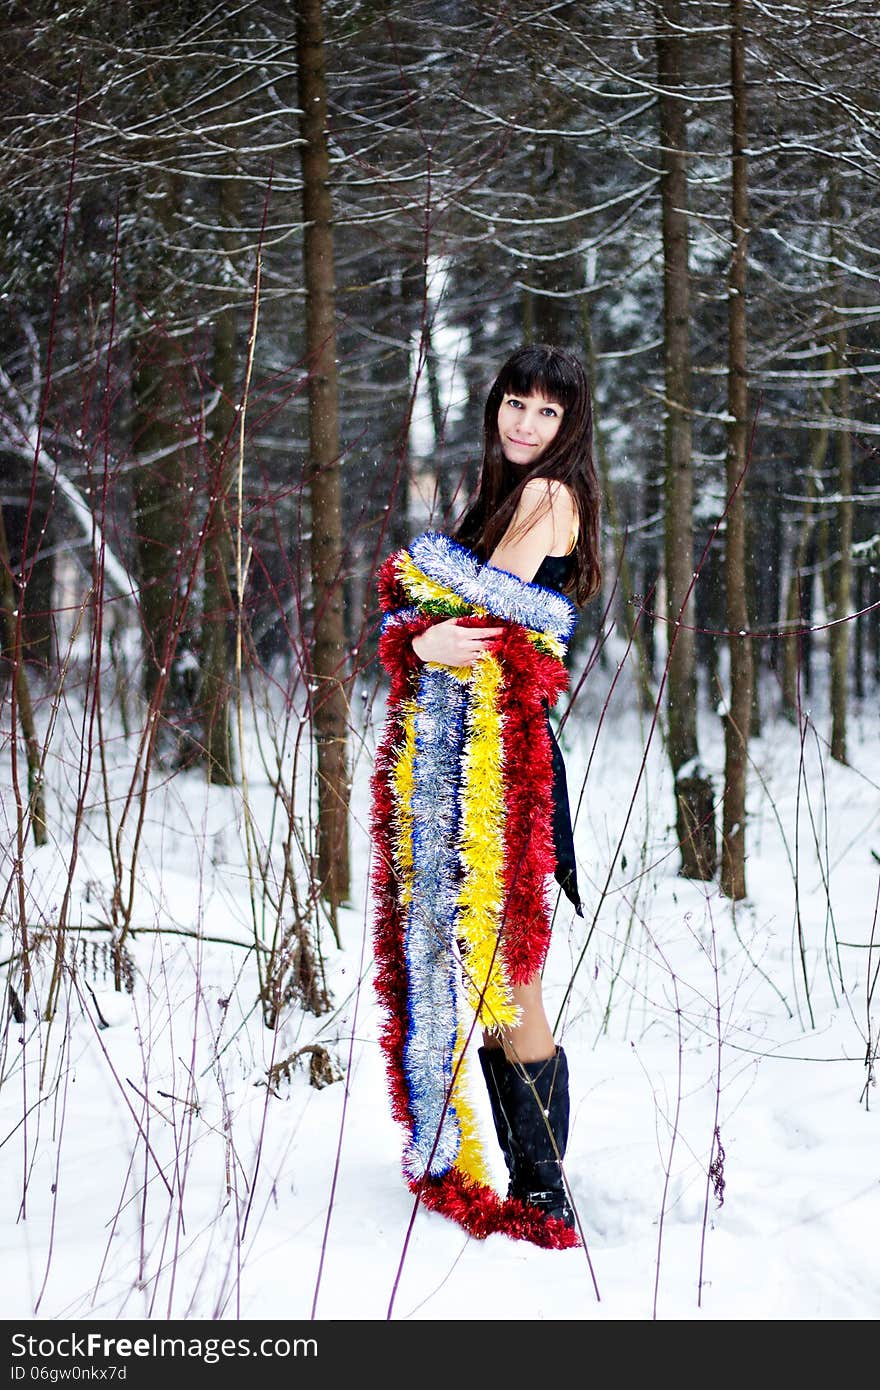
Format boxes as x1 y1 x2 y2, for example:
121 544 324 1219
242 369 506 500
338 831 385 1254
373 345 601 1247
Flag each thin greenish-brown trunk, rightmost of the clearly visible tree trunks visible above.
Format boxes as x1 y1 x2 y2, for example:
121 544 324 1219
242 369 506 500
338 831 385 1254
829 179 852 763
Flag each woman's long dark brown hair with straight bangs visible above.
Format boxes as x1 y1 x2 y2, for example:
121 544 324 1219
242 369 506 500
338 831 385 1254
453 343 602 603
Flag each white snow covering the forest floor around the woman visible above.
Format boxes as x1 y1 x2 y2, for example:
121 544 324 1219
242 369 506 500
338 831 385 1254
0 650 880 1322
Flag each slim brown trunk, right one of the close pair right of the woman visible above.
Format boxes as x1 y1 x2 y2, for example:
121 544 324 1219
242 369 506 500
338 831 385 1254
720 0 752 901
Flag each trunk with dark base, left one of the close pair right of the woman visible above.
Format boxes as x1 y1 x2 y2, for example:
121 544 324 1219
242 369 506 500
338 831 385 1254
656 0 716 878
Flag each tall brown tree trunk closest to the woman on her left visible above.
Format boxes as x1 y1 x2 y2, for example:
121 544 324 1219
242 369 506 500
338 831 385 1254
296 0 350 910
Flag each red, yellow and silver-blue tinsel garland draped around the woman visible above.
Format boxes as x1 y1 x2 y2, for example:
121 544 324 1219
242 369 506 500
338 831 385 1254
371 532 578 1247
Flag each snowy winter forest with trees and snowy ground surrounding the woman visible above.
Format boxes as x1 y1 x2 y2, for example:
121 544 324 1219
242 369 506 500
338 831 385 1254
0 0 880 1321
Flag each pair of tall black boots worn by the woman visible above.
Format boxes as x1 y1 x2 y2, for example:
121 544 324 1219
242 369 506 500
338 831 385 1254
478 1047 574 1227
